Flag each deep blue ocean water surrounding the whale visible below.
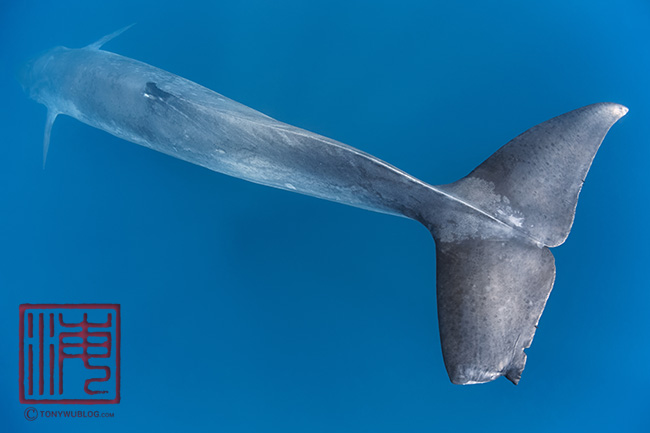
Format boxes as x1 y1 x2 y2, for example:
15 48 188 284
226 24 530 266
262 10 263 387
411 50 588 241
0 0 650 432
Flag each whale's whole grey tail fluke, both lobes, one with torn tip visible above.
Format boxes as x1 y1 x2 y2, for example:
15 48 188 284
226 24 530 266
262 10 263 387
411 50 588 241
428 103 627 384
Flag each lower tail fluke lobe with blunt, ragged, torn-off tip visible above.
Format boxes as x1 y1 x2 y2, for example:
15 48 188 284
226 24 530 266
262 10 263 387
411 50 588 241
436 237 555 384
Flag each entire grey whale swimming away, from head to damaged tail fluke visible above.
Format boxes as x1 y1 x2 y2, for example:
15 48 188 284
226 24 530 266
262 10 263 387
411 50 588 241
19 29 627 384
